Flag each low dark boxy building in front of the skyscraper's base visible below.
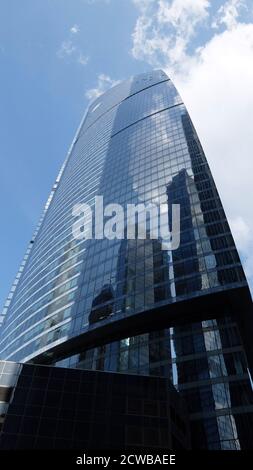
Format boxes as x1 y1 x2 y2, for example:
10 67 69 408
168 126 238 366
0 362 190 452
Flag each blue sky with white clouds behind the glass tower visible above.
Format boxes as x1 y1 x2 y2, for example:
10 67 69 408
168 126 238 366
0 0 253 303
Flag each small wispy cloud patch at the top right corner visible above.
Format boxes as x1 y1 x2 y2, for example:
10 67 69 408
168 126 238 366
212 0 247 29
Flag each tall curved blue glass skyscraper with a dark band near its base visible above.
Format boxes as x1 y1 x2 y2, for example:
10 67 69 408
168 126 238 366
0 71 253 449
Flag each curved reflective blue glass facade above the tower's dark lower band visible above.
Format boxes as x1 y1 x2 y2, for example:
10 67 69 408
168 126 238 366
0 71 246 360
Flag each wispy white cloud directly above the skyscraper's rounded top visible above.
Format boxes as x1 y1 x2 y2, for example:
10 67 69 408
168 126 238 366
132 0 210 72
